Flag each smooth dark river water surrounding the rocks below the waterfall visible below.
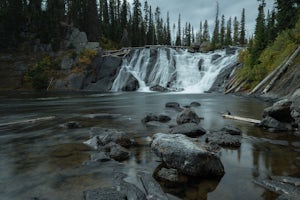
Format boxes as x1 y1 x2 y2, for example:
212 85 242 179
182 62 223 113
0 92 300 200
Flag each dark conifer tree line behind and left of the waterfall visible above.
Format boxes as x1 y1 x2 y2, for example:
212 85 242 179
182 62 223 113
0 0 246 49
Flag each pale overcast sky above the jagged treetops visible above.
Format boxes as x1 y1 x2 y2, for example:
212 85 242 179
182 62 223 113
128 0 274 37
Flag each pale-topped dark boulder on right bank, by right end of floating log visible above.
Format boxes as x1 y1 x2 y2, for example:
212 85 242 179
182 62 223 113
263 99 293 123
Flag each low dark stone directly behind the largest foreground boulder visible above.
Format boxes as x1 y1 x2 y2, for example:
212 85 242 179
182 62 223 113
170 123 206 137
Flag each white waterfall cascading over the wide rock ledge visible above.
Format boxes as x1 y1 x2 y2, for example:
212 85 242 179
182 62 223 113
112 47 237 93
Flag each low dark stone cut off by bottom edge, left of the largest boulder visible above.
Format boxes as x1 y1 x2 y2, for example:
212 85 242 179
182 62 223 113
83 188 127 200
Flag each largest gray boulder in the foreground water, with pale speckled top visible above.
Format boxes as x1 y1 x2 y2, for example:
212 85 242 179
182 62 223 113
151 133 225 177
